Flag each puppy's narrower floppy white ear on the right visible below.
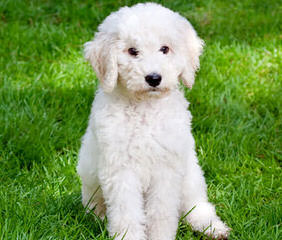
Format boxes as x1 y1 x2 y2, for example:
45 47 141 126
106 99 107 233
180 20 204 88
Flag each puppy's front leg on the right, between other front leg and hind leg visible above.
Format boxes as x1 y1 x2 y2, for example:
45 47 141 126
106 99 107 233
145 168 181 240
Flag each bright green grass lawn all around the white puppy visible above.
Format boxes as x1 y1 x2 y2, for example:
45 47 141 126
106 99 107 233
0 0 282 240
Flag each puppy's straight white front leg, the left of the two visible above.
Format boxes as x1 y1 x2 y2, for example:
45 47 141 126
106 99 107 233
101 169 146 240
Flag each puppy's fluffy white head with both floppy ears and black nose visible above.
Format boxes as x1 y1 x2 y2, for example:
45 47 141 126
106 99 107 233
85 3 203 96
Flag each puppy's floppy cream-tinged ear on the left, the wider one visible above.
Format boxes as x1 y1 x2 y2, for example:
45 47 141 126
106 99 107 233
84 32 118 92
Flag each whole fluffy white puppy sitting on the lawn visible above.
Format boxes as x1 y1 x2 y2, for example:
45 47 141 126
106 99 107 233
77 3 229 240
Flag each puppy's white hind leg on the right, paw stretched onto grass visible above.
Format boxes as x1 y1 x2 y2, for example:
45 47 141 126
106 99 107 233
182 153 230 239
